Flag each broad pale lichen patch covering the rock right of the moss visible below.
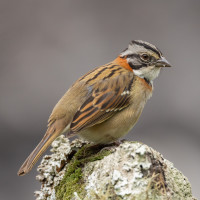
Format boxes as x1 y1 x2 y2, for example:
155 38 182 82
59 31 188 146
84 142 196 200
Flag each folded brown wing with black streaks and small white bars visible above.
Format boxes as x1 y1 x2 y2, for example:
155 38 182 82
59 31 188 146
70 71 134 133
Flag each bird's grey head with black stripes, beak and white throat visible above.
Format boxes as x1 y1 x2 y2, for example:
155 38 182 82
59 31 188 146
120 40 171 83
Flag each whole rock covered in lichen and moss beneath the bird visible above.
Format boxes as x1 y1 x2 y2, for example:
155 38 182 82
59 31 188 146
35 136 195 200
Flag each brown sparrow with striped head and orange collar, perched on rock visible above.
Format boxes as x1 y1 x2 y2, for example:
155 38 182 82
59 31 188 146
18 40 170 176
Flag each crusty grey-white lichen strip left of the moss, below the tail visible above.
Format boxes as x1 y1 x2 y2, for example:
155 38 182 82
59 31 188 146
35 135 71 200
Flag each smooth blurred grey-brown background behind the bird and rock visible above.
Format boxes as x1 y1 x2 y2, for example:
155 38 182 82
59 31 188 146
0 0 200 200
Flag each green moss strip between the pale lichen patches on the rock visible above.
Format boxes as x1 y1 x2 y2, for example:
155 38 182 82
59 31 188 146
55 144 111 200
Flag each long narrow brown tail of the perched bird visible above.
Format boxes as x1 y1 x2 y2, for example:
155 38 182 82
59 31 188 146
17 124 66 176
